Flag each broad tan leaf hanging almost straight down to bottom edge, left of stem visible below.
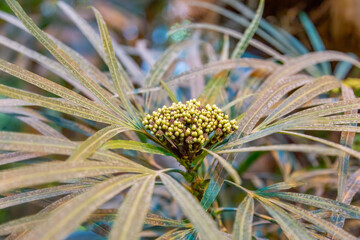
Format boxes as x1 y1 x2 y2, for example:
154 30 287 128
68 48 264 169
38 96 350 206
109 175 156 240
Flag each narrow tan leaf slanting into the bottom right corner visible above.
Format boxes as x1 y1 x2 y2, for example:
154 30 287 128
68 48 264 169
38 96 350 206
271 199 357 240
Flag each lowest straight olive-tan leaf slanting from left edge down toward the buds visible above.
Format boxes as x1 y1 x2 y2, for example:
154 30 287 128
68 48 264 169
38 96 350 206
0 84 122 124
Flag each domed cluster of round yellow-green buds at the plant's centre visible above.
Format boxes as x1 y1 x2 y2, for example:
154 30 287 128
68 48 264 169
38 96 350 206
143 99 237 162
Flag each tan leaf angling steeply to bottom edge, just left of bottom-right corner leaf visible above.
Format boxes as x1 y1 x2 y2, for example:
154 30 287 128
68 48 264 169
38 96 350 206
258 197 315 240
